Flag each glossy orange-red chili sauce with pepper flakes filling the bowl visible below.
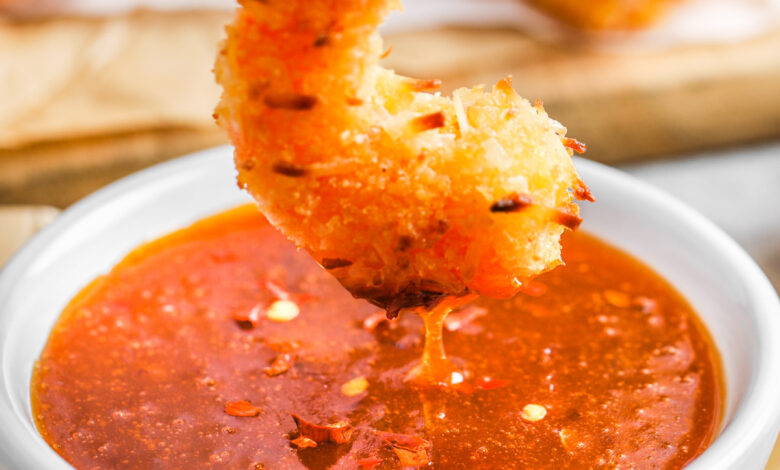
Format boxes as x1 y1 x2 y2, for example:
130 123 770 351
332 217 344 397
32 207 722 469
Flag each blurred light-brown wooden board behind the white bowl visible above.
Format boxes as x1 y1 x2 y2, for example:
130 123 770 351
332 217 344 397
0 12 780 207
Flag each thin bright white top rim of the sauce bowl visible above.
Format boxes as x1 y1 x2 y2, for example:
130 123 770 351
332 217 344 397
0 145 780 469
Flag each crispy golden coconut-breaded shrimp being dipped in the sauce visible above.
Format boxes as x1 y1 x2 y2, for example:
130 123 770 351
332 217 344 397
215 0 591 314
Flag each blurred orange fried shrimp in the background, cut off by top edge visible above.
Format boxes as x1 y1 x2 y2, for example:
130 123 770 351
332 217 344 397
527 0 681 30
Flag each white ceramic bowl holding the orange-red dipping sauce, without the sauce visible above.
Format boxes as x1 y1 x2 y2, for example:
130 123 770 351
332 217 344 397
0 147 780 470
